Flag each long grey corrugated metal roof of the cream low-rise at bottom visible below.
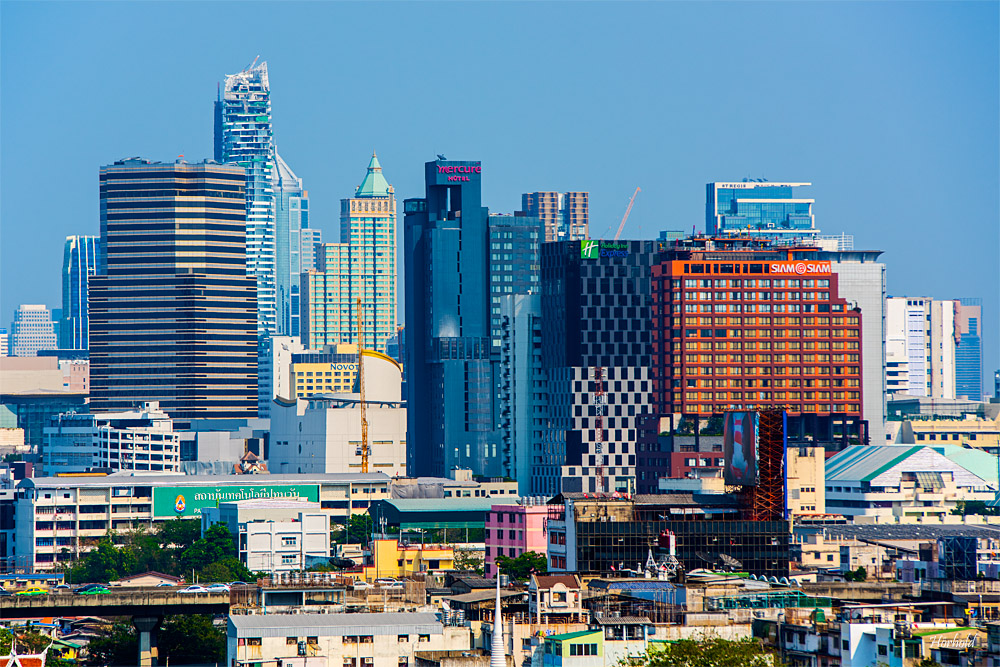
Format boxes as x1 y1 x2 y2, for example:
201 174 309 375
229 612 444 637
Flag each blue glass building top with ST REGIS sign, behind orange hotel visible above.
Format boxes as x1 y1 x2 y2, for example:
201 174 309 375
705 179 819 239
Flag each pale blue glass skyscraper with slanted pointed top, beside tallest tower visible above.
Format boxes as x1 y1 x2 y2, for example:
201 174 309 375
274 153 313 336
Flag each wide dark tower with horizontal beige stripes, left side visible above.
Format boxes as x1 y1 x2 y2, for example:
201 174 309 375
89 158 257 420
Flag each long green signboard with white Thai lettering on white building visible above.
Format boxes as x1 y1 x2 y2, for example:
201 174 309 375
153 484 319 519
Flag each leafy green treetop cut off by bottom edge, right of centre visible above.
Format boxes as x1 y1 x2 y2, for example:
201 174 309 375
637 637 782 667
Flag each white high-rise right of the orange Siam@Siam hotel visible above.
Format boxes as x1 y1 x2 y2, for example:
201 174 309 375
885 297 959 398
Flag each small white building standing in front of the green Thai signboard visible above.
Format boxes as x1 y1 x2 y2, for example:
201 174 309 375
201 498 330 574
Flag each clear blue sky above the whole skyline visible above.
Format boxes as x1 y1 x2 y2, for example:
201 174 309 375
0 1 1000 389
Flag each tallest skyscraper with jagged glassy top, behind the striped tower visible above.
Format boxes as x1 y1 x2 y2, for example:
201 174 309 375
215 60 278 335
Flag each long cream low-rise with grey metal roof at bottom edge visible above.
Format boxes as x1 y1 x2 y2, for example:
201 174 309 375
226 612 470 667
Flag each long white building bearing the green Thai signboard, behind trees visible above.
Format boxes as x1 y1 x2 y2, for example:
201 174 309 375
14 472 390 570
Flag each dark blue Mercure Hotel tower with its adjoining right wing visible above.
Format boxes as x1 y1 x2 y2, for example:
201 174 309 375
403 159 542 476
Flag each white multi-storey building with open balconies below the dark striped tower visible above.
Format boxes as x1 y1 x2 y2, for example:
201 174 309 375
41 402 180 476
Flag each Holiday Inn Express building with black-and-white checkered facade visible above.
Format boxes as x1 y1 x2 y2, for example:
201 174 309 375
532 241 656 494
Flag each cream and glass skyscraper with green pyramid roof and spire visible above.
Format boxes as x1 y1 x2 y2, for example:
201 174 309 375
302 154 396 352
